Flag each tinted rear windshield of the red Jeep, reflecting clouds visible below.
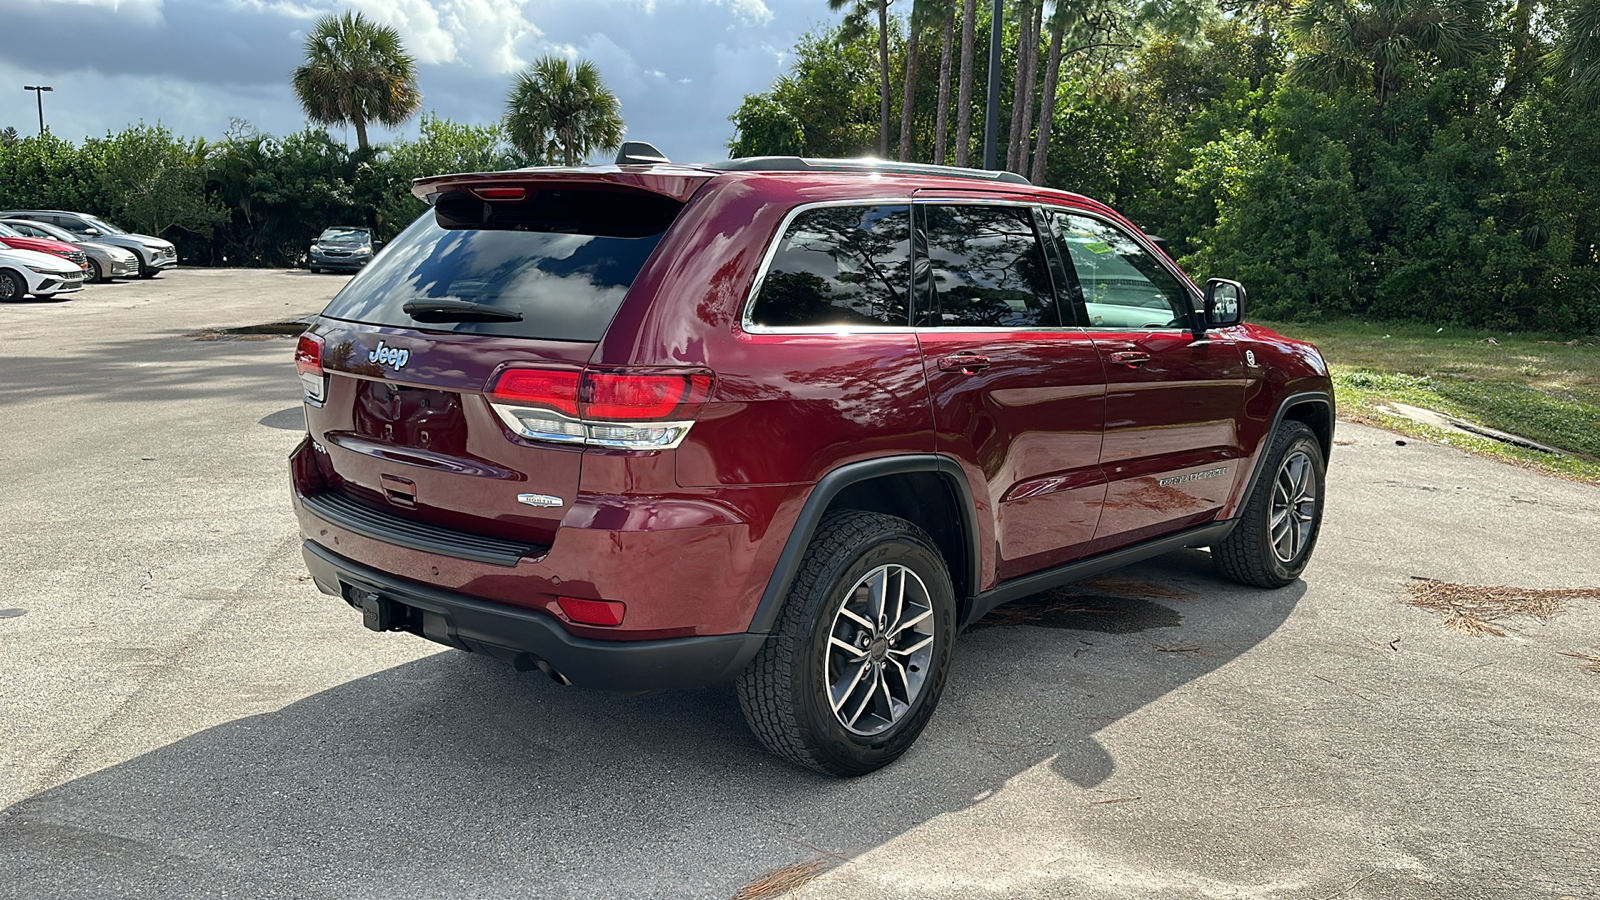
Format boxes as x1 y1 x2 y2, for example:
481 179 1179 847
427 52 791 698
323 191 680 341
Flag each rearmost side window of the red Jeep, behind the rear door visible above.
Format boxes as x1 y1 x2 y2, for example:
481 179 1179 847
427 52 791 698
750 207 910 327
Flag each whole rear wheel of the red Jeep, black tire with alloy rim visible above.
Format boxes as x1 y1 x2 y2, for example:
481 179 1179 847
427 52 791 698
738 509 955 777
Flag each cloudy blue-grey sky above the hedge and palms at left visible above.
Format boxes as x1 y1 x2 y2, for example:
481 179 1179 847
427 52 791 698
0 0 837 160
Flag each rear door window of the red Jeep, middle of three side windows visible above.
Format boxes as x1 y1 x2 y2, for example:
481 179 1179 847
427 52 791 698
917 203 1061 328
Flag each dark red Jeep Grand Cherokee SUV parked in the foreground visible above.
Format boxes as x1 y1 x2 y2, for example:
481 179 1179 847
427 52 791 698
293 149 1333 775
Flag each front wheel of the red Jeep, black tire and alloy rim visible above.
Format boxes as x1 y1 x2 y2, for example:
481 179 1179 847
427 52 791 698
1211 420 1328 588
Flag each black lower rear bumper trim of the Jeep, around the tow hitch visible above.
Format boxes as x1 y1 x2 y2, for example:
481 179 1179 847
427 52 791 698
301 541 766 690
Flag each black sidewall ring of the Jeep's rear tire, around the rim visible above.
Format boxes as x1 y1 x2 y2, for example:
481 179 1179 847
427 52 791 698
794 533 955 772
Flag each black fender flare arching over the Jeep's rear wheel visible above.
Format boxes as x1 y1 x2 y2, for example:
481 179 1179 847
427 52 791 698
749 453 979 634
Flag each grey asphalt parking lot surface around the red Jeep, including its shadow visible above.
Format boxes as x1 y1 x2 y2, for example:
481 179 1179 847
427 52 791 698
0 269 1600 900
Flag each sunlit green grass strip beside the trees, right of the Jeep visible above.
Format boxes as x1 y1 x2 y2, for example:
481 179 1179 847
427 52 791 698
1269 320 1600 484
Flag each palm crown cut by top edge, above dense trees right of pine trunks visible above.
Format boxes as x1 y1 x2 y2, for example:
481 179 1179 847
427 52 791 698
1290 0 1486 110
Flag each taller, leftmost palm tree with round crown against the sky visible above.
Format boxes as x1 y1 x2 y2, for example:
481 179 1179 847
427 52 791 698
290 11 422 151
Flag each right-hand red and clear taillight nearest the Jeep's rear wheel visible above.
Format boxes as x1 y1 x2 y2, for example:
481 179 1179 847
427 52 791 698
488 368 712 450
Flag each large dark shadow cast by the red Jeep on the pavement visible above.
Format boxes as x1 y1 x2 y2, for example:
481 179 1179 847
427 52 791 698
0 551 1304 898
